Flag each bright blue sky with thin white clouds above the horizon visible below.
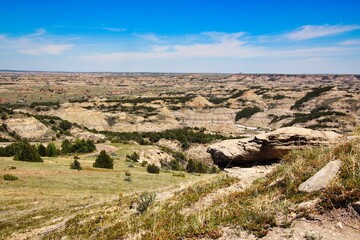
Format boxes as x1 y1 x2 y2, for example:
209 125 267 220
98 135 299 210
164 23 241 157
0 0 360 74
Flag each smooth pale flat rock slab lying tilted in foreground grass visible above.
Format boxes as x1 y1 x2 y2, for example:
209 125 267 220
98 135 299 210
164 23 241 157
299 160 342 192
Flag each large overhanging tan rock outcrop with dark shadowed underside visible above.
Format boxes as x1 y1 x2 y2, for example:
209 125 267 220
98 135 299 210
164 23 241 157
208 127 340 165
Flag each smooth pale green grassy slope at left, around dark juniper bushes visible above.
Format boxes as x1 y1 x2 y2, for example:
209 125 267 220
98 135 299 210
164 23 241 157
0 144 211 239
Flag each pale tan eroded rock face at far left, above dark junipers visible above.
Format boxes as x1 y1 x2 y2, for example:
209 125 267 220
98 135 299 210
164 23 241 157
5 117 51 141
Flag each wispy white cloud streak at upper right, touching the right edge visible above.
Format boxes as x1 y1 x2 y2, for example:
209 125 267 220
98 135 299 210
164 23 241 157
285 25 360 41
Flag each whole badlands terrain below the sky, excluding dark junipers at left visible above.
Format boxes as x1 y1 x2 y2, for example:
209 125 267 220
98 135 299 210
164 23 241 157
0 71 360 239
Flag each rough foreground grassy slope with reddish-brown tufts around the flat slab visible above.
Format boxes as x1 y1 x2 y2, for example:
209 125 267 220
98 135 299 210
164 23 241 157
38 129 360 239
